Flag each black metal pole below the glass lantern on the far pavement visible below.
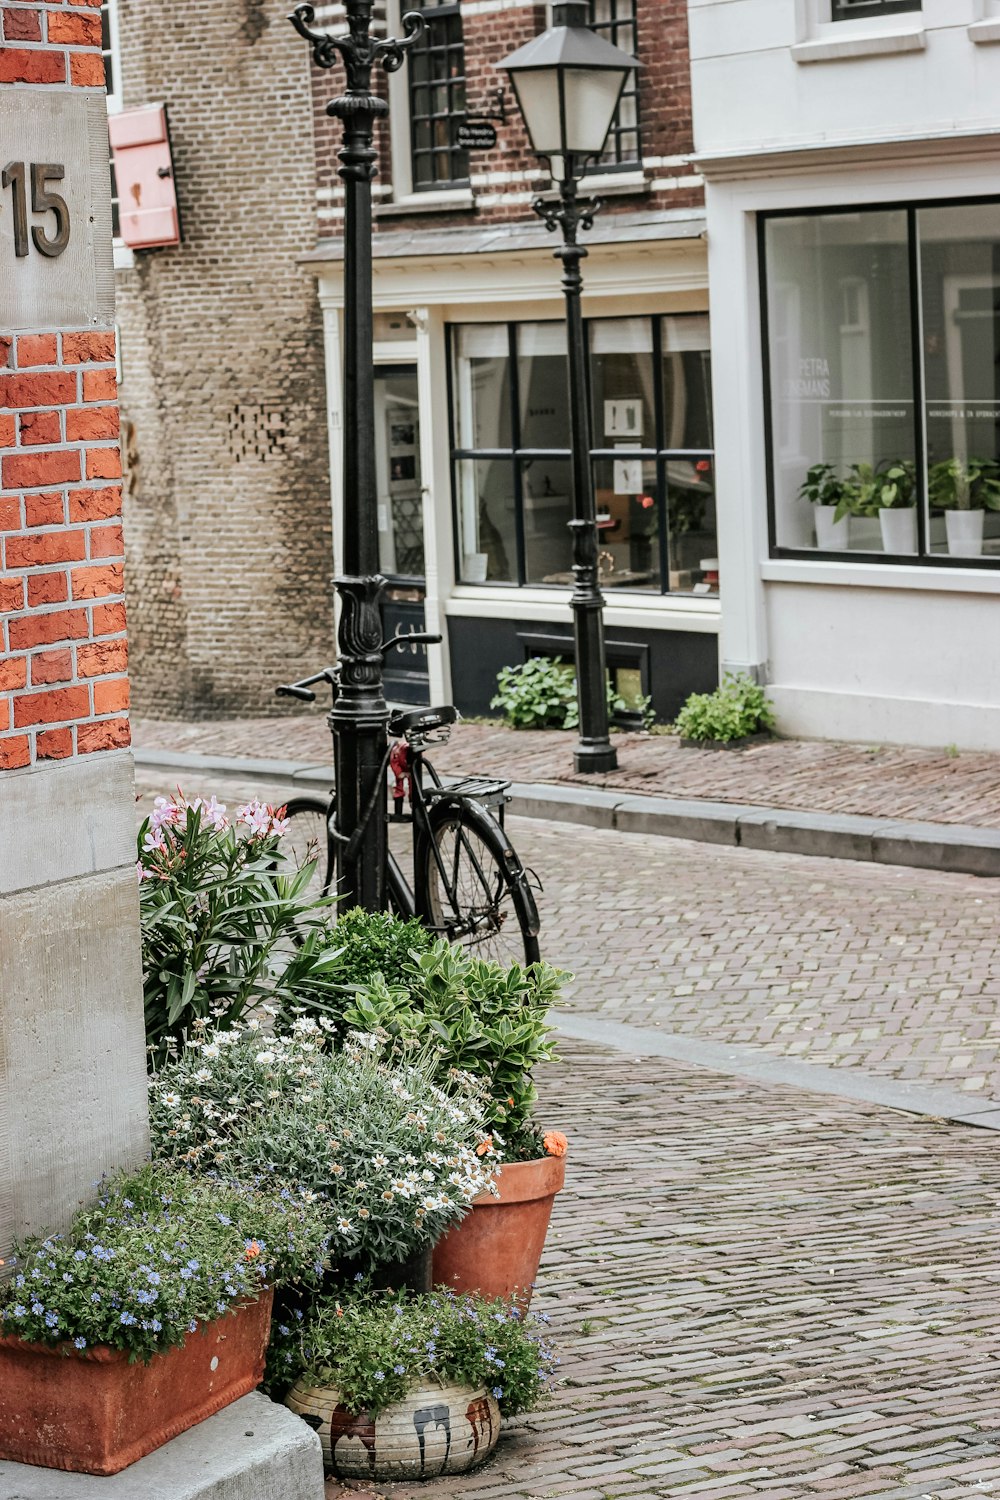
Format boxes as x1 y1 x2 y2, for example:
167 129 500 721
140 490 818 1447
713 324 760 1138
535 175 618 773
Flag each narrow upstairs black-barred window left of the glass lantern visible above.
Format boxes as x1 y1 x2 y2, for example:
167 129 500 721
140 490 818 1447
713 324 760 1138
405 0 469 192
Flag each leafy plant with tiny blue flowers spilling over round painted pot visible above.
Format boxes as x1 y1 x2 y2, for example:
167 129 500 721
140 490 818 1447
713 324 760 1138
268 1290 555 1418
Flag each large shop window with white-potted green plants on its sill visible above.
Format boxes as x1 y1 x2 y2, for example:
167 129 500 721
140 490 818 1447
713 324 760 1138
763 204 1000 563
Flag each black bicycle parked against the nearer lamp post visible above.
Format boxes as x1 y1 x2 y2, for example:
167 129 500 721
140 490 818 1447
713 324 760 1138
274 633 540 963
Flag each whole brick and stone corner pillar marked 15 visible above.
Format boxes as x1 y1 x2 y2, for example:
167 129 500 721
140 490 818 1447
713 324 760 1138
0 0 147 1257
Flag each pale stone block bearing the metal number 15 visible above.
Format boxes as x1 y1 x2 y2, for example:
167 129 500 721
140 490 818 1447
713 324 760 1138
0 89 114 333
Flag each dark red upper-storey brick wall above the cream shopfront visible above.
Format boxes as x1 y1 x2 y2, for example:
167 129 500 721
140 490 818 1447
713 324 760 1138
313 0 695 237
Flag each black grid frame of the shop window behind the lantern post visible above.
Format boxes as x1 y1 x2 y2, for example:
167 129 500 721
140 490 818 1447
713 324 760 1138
445 309 718 600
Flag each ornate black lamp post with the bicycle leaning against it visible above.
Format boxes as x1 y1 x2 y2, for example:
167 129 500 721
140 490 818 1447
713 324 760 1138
288 0 424 912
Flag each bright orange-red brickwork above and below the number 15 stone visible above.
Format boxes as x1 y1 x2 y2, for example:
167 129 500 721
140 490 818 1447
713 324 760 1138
0 0 129 770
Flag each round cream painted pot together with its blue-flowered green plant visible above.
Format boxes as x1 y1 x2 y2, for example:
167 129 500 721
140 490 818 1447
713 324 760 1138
283 1292 555 1481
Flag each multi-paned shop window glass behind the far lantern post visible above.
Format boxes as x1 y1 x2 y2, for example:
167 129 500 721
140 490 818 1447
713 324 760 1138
453 314 718 594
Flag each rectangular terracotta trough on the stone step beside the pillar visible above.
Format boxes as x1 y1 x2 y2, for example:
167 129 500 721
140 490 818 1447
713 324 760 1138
0 1292 273 1475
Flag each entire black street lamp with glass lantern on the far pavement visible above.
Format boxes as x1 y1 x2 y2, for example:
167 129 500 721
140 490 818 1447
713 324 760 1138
499 0 639 771
